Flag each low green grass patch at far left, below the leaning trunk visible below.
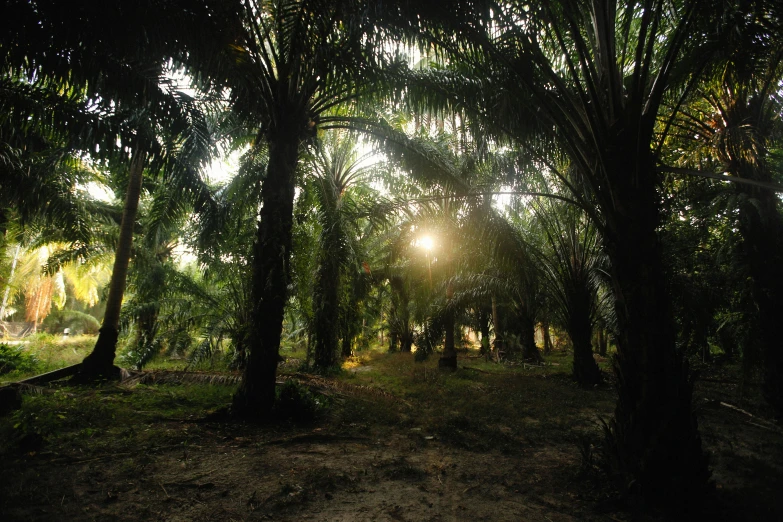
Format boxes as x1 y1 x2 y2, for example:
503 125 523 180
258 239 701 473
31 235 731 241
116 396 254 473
0 384 234 455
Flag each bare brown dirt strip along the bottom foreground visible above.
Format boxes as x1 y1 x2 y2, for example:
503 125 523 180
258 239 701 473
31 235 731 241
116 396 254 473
0 425 611 521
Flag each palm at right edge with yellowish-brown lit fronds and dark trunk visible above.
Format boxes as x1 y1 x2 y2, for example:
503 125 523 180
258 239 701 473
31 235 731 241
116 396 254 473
677 7 783 415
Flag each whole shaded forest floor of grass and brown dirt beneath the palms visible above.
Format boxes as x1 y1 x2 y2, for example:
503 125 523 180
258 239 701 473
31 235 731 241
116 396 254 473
0 344 783 522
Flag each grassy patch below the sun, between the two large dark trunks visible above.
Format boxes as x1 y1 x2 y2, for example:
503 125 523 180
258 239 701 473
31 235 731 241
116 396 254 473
338 351 614 452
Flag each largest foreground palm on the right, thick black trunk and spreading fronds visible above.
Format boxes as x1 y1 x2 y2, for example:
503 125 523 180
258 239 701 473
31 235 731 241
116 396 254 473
380 0 718 506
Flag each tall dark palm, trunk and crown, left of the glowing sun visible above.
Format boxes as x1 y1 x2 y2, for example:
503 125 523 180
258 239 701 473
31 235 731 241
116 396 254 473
220 0 402 416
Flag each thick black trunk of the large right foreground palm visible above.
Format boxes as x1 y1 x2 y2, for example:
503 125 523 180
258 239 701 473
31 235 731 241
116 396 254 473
602 152 710 508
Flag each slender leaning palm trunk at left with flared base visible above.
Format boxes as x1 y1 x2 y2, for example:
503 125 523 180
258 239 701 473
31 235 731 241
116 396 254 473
77 151 146 381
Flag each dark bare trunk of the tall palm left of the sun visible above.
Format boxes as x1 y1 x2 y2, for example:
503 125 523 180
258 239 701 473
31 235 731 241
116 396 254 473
233 132 299 417
